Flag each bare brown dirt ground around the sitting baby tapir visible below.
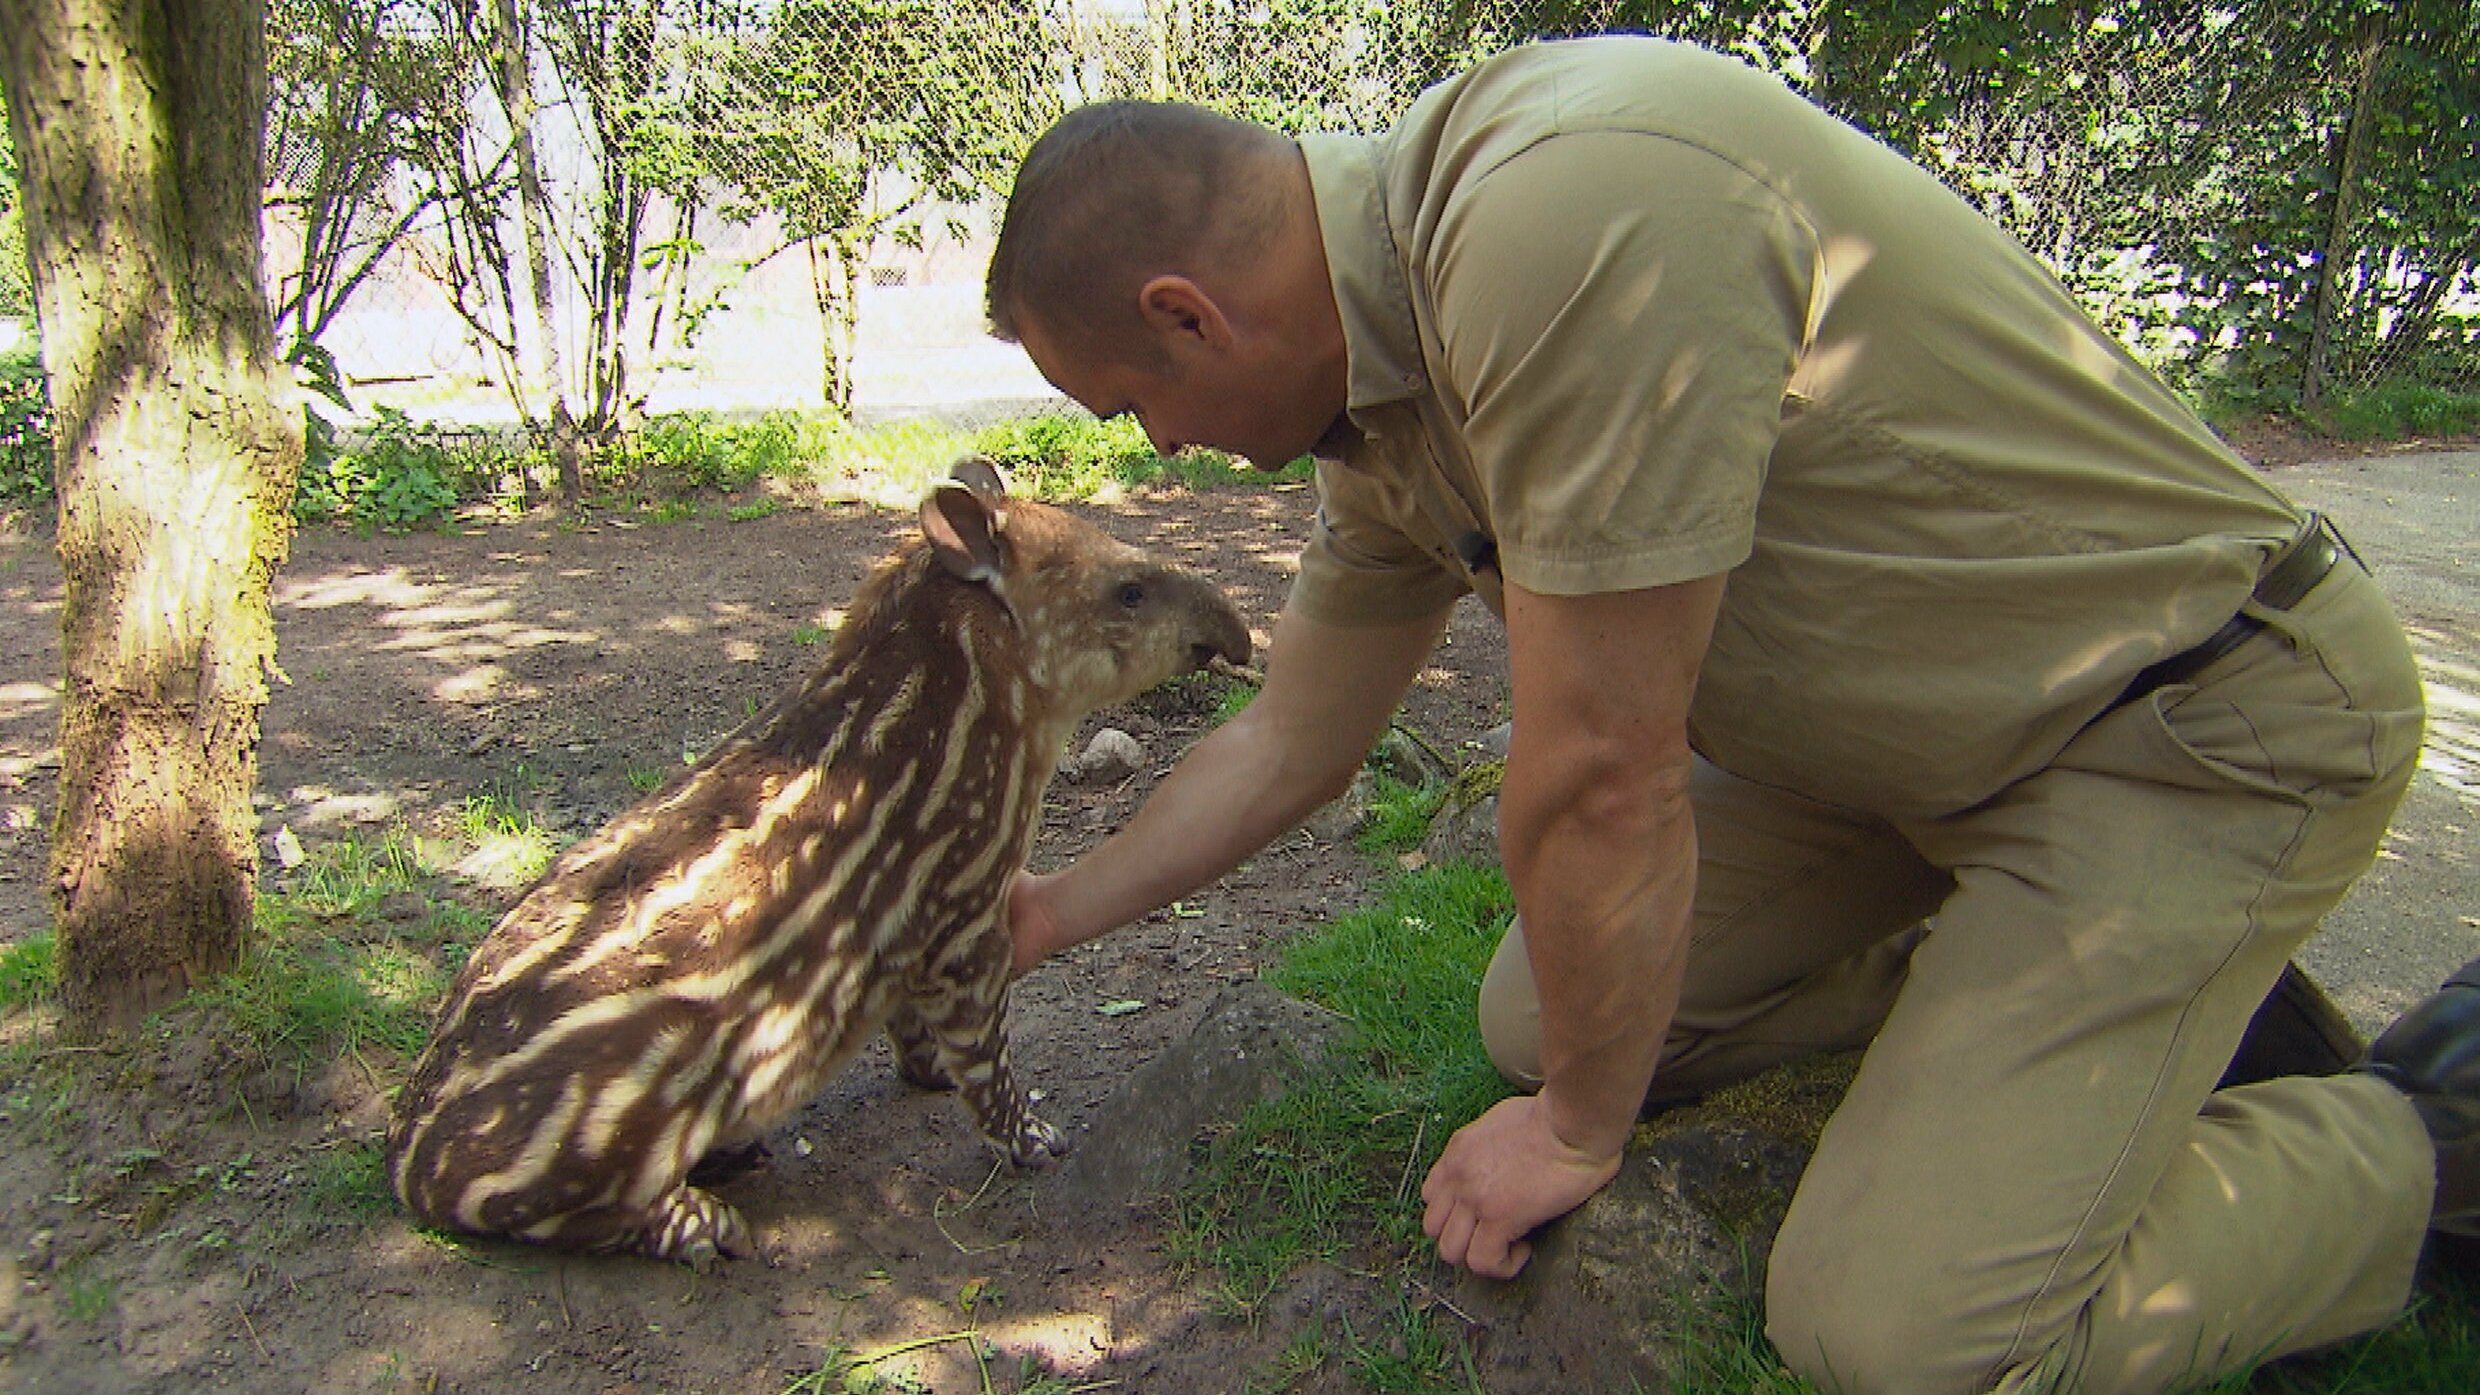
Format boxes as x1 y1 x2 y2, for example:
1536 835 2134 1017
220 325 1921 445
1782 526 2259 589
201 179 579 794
0 476 1503 1395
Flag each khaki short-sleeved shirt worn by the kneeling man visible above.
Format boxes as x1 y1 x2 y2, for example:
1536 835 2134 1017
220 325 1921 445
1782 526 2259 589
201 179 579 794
1295 37 2299 817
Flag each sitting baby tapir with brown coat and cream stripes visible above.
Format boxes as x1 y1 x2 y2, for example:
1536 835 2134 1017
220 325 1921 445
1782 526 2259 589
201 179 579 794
387 459 1250 1266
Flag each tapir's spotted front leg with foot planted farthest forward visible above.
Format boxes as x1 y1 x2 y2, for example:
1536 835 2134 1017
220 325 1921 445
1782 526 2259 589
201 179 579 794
907 923 1069 1167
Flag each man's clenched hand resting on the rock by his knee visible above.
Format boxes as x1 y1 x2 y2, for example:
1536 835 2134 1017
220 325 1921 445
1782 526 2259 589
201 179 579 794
1421 1095 1619 1278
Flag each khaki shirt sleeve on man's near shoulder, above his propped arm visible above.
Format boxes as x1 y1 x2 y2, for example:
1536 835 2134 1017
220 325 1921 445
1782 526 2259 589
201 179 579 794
1428 132 1818 596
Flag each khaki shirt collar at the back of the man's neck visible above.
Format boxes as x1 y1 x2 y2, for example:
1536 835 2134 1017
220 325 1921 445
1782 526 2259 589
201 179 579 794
1300 132 1428 415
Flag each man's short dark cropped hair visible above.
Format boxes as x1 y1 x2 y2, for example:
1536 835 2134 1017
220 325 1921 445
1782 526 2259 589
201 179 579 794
985 102 1292 352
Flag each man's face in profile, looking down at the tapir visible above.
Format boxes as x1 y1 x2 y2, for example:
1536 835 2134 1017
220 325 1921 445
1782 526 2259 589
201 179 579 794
1022 325 1342 469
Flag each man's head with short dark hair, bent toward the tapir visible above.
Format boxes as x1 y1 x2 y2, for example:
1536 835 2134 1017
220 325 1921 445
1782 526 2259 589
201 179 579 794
987 102 1344 469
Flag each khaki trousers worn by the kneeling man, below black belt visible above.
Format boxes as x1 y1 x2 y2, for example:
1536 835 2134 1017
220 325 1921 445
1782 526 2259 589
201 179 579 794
1481 561 2435 1395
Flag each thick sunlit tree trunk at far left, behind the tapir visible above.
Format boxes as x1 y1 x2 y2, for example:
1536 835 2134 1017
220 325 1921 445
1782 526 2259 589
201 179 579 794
0 0 303 1030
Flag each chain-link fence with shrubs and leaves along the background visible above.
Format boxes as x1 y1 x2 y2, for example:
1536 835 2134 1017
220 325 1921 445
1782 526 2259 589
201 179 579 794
270 0 2480 429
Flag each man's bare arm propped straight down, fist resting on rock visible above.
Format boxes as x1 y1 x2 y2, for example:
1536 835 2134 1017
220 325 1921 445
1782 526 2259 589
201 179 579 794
1421 565 1721 1278
